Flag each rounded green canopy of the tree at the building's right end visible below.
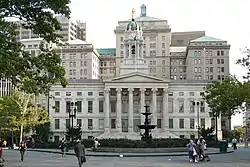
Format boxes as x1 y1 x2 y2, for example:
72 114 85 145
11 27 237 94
203 77 250 117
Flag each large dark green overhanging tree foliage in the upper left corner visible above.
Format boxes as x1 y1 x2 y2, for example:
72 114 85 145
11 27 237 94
0 0 70 94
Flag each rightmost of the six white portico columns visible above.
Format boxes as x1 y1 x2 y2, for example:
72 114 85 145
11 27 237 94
162 88 169 132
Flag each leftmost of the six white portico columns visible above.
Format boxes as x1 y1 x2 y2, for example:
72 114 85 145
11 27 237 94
104 89 110 133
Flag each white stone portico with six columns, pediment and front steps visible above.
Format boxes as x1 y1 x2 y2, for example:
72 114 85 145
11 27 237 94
97 72 178 139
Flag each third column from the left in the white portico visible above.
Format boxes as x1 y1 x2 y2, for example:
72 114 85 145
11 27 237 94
128 88 134 132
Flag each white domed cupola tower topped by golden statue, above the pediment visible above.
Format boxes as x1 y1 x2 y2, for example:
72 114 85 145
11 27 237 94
120 9 149 75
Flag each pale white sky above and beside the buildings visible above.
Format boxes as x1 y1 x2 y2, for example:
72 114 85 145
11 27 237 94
70 0 250 129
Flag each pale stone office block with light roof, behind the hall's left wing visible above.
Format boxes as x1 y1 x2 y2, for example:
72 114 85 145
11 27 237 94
56 39 100 80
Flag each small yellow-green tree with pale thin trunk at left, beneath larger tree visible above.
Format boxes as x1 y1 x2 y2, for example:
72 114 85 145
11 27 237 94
0 89 48 141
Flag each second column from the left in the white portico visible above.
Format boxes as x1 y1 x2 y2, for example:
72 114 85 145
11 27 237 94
116 88 122 132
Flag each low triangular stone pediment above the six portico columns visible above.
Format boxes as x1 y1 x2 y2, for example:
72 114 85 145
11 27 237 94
106 72 167 83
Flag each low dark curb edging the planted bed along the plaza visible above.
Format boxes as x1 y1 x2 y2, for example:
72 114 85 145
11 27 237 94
25 150 234 157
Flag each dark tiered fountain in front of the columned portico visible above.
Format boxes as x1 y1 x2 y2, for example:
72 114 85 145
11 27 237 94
138 105 156 143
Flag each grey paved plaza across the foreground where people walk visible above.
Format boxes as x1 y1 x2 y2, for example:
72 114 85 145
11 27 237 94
1 148 250 167
